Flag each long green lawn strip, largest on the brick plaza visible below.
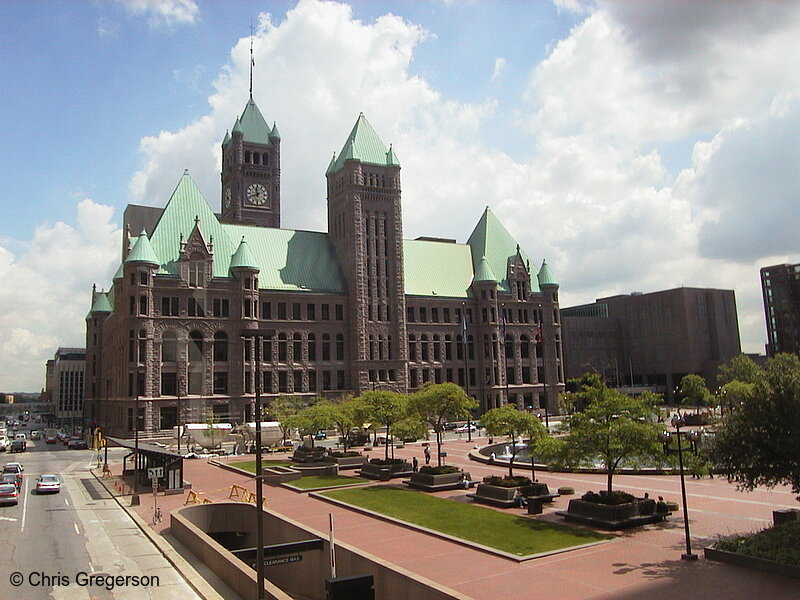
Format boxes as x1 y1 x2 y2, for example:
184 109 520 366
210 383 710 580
322 486 613 556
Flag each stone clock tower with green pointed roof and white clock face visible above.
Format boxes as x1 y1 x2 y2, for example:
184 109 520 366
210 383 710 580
221 96 281 227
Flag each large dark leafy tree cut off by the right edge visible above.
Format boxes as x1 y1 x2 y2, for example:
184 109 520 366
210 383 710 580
710 354 800 500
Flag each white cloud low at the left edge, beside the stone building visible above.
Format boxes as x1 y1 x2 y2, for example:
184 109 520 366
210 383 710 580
0 199 121 391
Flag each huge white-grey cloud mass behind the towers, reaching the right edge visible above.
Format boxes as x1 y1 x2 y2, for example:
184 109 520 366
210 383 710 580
125 0 800 366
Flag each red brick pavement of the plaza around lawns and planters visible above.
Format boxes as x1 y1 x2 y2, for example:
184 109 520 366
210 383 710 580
108 440 800 600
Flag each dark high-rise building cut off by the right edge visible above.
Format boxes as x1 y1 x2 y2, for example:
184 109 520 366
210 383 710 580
761 264 800 356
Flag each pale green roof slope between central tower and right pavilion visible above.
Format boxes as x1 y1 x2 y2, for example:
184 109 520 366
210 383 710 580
403 240 472 298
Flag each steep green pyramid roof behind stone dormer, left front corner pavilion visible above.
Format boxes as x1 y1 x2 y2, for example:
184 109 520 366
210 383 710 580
151 171 241 277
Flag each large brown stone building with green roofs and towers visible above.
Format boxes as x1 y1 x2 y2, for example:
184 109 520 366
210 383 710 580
86 98 563 436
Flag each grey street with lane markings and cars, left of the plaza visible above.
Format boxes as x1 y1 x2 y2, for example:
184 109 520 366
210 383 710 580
0 426 197 600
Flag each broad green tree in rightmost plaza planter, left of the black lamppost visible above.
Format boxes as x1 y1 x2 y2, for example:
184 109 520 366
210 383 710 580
551 387 662 495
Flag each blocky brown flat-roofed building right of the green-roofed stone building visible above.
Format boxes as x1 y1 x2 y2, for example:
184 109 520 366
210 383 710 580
561 288 741 399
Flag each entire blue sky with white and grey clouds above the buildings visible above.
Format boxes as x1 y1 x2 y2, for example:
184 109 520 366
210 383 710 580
0 0 800 392
